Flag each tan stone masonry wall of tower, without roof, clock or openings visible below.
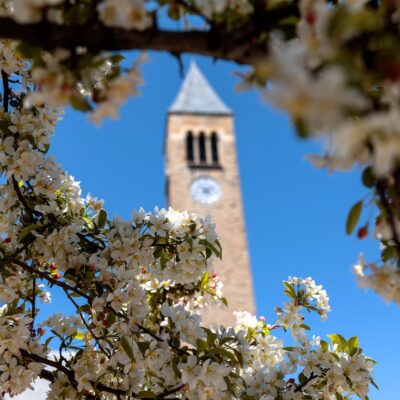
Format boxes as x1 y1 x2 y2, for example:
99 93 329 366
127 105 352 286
165 114 255 326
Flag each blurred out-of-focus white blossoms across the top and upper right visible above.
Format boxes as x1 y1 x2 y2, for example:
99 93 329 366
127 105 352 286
0 0 400 304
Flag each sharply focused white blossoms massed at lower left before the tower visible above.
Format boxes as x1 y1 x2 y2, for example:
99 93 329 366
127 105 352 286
0 36 373 400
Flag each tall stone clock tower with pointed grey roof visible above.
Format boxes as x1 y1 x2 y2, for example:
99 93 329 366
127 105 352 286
165 62 255 325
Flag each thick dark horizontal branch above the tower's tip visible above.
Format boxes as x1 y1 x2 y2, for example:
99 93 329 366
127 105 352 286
0 4 298 64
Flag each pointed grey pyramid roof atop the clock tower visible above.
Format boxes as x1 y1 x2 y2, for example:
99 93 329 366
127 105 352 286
168 61 232 115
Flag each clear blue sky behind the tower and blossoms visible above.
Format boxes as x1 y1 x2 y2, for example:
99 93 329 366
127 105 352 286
52 53 400 400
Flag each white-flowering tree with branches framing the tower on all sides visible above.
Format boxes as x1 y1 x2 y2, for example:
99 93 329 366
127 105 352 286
0 0 394 400
